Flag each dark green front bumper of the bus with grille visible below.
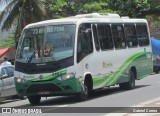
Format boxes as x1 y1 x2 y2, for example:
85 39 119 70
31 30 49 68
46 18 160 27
15 77 82 96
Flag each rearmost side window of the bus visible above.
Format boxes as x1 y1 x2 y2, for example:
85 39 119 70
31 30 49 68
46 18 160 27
136 24 149 46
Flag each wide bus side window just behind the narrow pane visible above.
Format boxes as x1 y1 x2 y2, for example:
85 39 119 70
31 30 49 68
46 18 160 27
97 24 113 50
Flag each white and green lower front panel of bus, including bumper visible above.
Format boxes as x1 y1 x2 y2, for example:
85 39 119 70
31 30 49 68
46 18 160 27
15 66 82 96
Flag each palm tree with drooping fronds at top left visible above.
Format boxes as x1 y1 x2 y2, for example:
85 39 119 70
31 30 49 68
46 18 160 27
0 0 47 46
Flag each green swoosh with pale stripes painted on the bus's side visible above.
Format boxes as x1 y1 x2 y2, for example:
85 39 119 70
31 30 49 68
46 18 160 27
93 52 152 87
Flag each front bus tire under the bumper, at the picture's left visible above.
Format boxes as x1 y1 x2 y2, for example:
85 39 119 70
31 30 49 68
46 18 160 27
28 96 41 105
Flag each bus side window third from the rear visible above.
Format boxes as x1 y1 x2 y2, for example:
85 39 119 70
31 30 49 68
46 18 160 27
111 24 126 49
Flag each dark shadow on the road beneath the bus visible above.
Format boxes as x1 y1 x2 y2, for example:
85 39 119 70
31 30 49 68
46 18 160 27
20 85 150 107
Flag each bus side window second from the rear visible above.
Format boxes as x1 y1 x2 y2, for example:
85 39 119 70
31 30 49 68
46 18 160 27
124 24 138 47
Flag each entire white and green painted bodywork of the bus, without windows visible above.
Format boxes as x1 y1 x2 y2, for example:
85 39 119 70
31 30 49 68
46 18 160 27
15 13 153 99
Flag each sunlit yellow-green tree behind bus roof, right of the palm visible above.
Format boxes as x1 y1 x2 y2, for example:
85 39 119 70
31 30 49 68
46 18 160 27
48 0 113 18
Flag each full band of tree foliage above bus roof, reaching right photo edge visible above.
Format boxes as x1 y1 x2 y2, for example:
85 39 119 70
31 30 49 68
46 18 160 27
48 0 160 18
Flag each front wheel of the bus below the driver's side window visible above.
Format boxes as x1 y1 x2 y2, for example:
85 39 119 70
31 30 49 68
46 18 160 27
77 82 89 101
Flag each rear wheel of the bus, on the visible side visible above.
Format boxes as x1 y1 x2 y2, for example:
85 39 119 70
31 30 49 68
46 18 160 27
119 70 135 90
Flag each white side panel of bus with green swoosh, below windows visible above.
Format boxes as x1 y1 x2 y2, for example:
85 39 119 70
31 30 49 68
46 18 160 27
77 47 152 89
